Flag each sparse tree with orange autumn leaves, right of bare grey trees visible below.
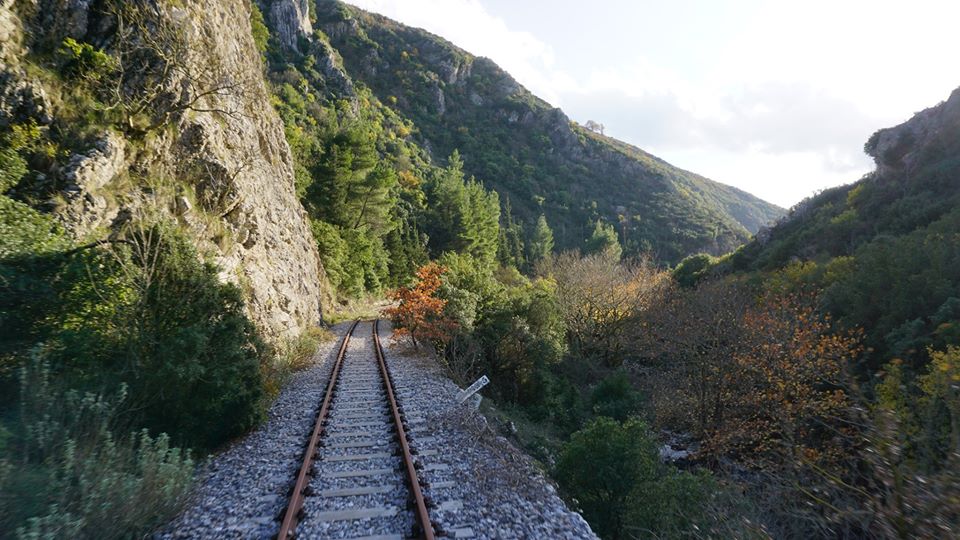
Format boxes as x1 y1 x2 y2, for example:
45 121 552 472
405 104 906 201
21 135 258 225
717 295 862 462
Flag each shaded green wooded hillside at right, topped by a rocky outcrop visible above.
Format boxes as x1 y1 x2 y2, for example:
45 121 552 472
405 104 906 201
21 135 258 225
720 89 960 370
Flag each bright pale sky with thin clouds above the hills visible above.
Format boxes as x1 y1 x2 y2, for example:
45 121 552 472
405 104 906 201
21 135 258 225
348 0 960 207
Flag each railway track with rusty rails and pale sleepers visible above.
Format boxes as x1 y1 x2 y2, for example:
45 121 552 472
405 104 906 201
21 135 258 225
277 320 443 540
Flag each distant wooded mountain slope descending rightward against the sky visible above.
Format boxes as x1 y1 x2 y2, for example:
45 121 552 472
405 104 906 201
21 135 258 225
317 0 782 261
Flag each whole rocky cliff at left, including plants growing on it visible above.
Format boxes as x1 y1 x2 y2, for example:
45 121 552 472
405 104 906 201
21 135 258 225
0 0 329 336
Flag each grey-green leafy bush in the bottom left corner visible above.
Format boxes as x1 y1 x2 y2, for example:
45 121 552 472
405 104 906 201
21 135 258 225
0 350 193 539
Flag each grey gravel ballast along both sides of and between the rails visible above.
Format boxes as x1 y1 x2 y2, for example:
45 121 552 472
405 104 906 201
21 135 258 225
156 322 596 539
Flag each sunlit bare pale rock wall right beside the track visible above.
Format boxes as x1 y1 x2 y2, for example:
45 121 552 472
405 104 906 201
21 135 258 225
169 0 330 335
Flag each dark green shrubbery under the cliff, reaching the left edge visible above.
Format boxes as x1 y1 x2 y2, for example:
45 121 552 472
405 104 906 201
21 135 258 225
0 219 270 449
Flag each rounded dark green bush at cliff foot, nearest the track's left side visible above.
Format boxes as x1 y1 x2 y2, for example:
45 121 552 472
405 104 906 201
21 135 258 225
91 223 269 448
